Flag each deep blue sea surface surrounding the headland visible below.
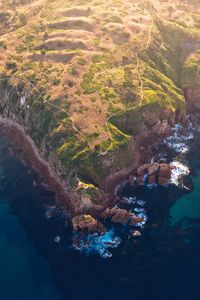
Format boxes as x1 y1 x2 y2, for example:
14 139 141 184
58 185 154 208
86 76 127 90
0 126 200 300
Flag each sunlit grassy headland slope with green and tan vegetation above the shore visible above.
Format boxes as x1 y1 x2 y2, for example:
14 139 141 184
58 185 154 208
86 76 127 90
0 0 200 206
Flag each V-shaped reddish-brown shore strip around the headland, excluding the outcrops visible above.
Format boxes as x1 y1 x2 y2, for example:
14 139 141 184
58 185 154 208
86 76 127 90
0 111 194 218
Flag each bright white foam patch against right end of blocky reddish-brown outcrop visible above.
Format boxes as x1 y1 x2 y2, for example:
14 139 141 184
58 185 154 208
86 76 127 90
170 161 190 186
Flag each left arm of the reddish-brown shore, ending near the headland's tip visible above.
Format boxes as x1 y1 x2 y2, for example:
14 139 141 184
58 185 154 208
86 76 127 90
0 117 81 216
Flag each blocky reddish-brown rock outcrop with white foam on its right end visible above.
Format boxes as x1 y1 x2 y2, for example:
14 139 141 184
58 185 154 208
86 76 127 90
137 163 172 185
